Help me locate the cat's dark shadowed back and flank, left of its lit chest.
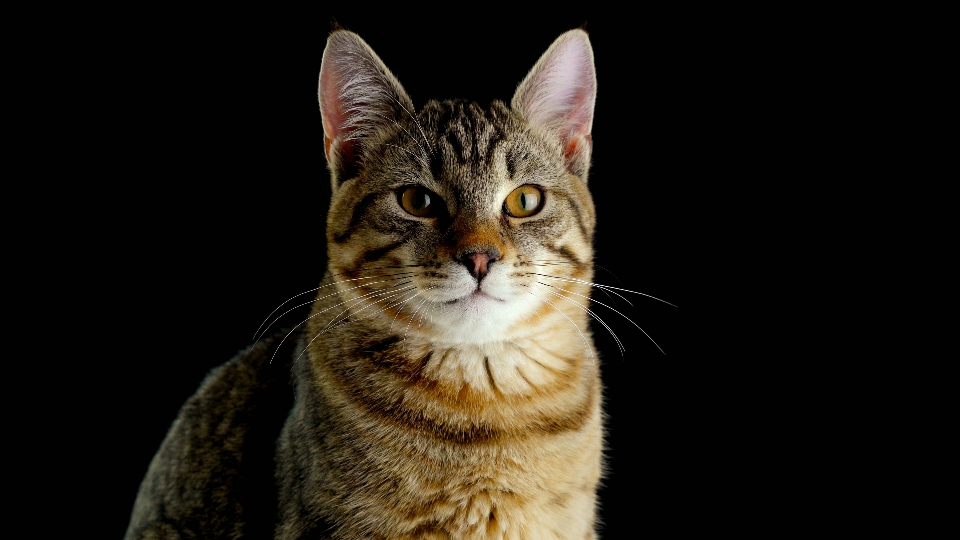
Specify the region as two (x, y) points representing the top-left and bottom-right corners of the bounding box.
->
(125, 332), (296, 539)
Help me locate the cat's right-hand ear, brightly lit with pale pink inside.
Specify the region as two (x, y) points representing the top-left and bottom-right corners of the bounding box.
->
(510, 29), (597, 182)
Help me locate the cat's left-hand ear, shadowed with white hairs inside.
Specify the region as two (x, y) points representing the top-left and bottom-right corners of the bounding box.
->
(317, 30), (413, 191)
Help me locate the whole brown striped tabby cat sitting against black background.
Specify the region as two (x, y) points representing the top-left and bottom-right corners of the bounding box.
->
(126, 30), (603, 540)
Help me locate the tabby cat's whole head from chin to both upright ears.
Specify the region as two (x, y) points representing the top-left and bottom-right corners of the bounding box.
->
(319, 30), (596, 343)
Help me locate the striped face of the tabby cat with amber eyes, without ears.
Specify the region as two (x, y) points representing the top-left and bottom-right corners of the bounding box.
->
(327, 102), (594, 342)
